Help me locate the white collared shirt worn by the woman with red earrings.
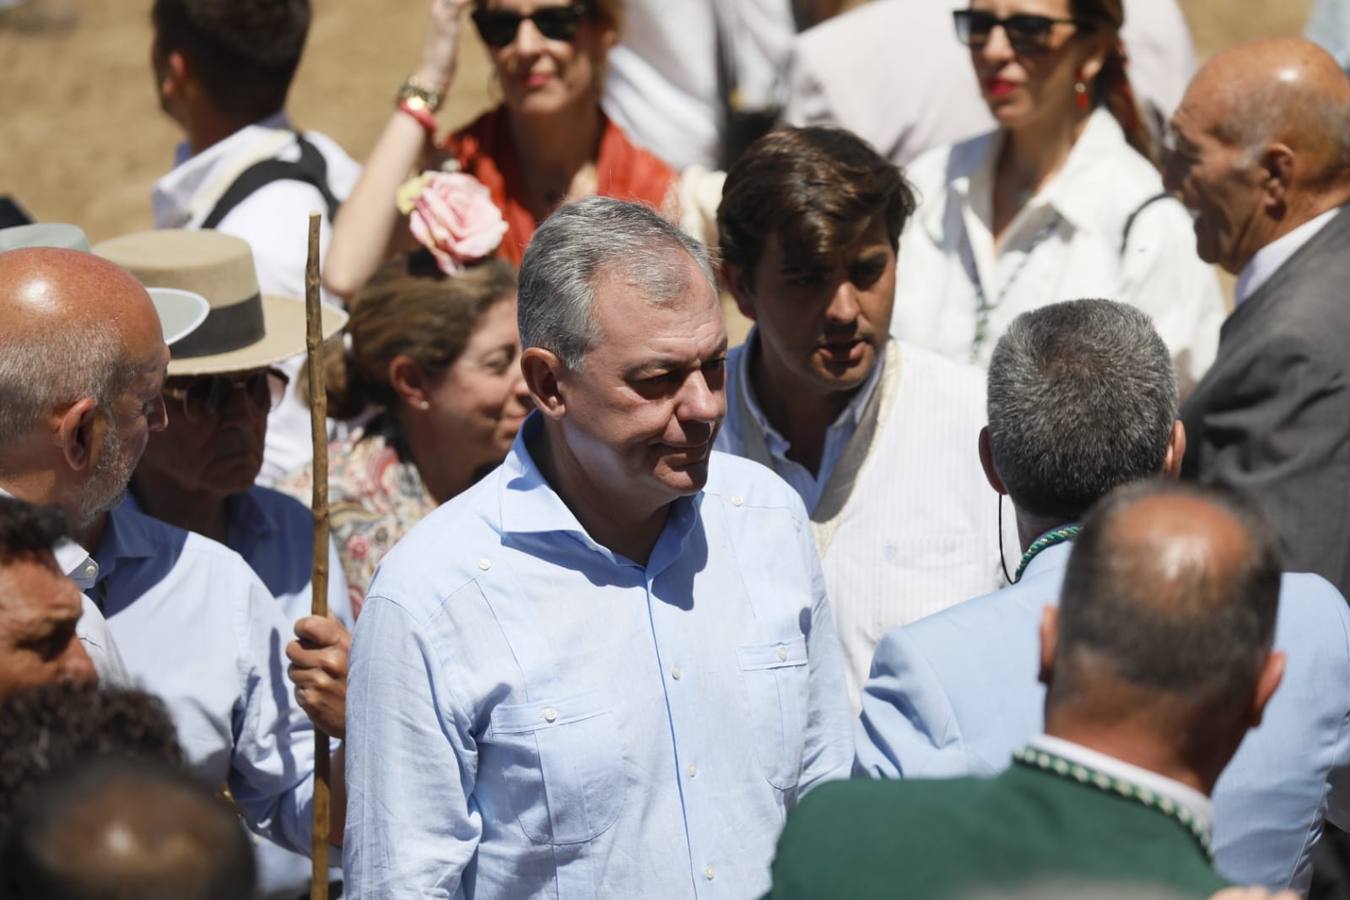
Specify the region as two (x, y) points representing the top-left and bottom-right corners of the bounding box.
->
(891, 109), (1224, 395)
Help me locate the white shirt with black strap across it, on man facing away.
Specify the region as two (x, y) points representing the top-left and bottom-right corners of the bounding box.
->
(151, 112), (360, 493)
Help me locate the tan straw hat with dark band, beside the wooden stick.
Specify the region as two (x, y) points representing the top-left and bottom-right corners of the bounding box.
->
(93, 228), (347, 376)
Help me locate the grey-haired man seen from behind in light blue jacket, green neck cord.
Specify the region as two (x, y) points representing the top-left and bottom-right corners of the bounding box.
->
(856, 300), (1350, 888)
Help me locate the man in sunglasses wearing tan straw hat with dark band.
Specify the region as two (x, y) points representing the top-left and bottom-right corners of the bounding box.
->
(95, 229), (351, 896)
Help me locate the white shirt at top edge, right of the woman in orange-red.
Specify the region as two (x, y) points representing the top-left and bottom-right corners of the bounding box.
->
(602, 0), (797, 170)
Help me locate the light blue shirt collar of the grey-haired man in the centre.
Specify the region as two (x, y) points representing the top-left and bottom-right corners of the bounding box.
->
(500, 410), (702, 568)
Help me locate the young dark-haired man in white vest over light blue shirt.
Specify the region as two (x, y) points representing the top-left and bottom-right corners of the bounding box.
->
(717, 128), (1011, 706)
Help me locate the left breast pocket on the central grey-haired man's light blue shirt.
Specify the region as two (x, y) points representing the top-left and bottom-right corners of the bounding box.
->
(483, 691), (626, 845)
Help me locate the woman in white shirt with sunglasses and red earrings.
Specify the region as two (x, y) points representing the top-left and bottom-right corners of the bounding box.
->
(892, 0), (1224, 391)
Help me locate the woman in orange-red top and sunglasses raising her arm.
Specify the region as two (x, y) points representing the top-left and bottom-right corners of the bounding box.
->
(324, 0), (679, 297)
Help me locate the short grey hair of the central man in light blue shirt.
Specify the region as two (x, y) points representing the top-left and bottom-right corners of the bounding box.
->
(517, 197), (717, 371)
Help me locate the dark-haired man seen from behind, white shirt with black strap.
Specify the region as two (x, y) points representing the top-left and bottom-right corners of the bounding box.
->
(151, 0), (360, 483)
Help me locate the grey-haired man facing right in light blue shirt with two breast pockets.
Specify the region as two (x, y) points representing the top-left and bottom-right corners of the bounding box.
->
(344, 198), (852, 899)
